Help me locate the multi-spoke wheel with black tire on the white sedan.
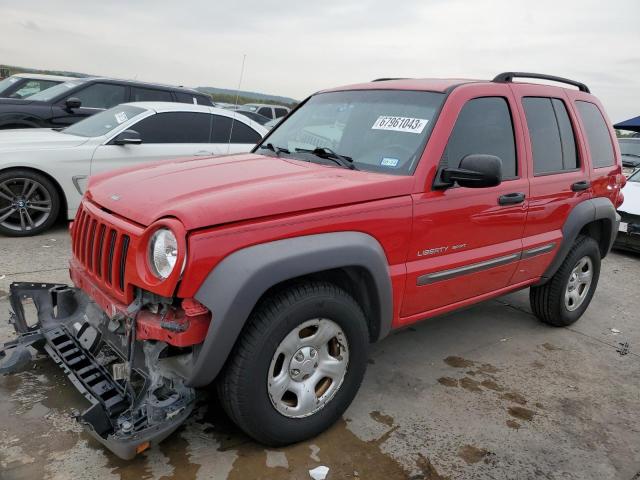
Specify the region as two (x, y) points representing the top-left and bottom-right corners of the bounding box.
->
(0, 170), (60, 237)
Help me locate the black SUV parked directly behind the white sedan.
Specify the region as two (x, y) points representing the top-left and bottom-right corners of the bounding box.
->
(0, 78), (213, 129)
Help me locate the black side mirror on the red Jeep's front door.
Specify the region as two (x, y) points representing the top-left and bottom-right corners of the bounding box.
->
(440, 154), (502, 188)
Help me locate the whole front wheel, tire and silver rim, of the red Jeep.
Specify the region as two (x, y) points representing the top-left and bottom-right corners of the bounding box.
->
(217, 282), (369, 446)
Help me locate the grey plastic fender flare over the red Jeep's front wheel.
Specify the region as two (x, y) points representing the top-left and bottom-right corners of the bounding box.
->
(188, 231), (393, 387)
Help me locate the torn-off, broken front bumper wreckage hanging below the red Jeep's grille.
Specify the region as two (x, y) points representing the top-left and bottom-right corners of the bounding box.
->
(0, 283), (200, 459)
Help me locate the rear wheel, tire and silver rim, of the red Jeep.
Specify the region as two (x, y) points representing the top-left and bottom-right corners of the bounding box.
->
(529, 235), (600, 327)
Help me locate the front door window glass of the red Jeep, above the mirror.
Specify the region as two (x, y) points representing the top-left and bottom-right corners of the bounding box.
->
(441, 97), (518, 179)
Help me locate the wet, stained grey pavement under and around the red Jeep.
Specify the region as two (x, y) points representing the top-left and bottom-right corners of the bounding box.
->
(0, 226), (640, 480)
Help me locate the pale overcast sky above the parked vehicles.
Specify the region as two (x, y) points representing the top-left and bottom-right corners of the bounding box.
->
(0, 0), (640, 122)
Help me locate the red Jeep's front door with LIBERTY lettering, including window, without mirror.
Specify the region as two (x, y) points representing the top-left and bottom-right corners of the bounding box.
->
(401, 90), (529, 323)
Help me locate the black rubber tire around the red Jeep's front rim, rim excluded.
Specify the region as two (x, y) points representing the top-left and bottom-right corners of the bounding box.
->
(217, 282), (369, 447)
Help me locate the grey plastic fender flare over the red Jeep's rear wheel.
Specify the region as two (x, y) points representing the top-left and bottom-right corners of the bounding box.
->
(538, 197), (620, 285)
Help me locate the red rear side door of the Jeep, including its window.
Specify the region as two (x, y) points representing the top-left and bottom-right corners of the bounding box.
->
(511, 84), (592, 282)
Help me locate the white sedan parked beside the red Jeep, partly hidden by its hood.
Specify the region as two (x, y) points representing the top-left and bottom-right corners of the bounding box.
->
(0, 102), (267, 236)
